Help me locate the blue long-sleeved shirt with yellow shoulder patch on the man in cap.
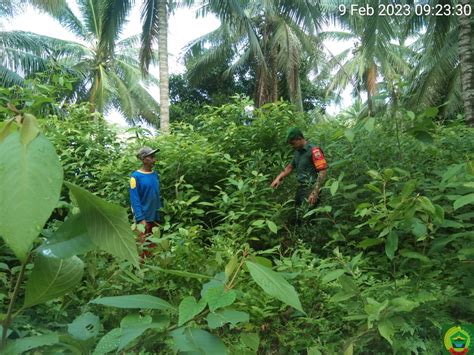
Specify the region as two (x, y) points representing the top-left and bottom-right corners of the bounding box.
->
(129, 170), (162, 223)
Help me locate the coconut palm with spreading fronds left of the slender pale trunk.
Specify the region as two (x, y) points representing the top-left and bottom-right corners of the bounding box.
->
(0, 0), (158, 125)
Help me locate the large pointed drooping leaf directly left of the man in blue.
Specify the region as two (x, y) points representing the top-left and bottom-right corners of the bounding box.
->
(66, 182), (138, 265)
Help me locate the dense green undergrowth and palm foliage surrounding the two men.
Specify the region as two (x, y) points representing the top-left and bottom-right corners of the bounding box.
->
(0, 0), (474, 354)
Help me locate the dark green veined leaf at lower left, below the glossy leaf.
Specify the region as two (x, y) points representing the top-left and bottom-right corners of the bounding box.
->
(24, 254), (84, 307)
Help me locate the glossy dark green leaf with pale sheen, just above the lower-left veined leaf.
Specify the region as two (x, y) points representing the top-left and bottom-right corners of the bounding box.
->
(39, 214), (96, 259)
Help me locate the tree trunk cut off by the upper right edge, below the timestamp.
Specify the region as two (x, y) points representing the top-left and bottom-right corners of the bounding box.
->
(459, 0), (474, 126)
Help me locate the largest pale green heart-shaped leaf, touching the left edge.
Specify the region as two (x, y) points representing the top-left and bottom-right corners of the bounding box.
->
(0, 132), (63, 262)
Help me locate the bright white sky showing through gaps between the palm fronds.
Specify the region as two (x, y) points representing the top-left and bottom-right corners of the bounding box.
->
(0, 1), (351, 127)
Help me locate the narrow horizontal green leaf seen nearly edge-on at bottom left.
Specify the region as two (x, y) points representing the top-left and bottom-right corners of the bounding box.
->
(90, 295), (176, 312)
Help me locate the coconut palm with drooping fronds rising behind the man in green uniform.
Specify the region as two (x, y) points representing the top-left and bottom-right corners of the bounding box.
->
(181, 0), (320, 110)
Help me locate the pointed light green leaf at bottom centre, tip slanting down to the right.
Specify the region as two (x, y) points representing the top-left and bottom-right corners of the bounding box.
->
(245, 261), (304, 313)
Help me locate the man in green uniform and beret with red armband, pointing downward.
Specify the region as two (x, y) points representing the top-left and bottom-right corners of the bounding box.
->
(271, 127), (327, 207)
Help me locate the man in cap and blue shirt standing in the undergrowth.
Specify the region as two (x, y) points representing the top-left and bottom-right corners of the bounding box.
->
(129, 147), (162, 257)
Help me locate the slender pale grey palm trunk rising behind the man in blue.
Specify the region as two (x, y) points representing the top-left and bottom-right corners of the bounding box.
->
(158, 0), (170, 133)
